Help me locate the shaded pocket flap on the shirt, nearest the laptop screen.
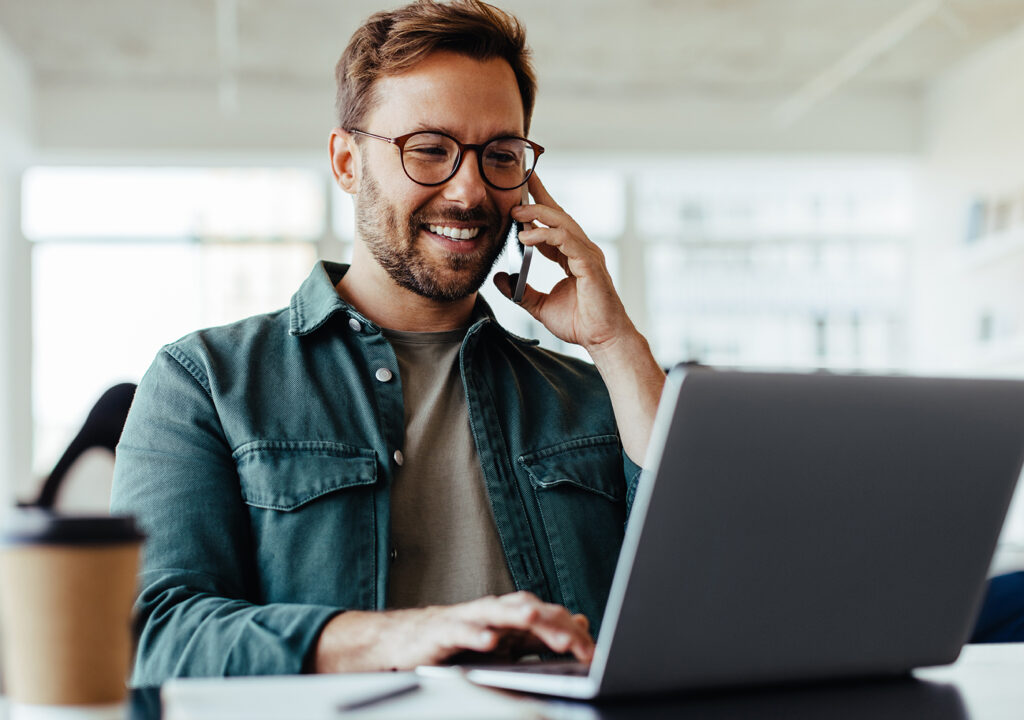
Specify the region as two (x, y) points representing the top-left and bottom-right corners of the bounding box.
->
(518, 435), (626, 502)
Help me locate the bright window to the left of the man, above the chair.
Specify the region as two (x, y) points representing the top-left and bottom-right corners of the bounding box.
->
(23, 168), (327, 475)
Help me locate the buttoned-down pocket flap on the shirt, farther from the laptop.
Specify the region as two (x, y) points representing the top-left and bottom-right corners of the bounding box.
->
(232, 440), (377, 512)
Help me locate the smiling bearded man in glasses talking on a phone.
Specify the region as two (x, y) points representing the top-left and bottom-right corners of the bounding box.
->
(113, 0), (664, 684)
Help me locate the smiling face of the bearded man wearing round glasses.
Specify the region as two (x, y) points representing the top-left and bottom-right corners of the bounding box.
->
(355, 52), (523, 300)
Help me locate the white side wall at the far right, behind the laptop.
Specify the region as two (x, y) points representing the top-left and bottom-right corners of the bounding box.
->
(911, 21), (1024, 568)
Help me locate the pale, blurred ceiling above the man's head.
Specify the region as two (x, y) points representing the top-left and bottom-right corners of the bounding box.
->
(0, 0), (1024, 150)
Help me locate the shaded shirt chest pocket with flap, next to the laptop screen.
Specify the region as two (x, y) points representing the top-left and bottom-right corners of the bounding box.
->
(517, 435), (626, 634)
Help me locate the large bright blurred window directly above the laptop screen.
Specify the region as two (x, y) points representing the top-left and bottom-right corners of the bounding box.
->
(636, 159), (914, 370)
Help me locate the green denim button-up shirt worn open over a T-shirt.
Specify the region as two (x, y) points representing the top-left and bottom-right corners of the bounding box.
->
(112, 262), (640, 685)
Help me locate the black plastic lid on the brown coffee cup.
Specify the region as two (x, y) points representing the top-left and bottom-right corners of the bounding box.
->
(0, 510), (145, 545)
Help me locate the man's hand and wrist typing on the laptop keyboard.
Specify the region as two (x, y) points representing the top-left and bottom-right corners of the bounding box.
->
(310, 592), (594, 673)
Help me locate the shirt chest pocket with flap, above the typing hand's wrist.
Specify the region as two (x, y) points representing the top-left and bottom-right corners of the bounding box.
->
(233, 440), (377, 609)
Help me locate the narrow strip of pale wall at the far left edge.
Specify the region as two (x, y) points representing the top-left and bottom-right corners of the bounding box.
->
(0, 29), (32, 505)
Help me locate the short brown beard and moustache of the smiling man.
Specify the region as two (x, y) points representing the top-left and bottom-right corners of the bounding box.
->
(355, 168), (512, 301)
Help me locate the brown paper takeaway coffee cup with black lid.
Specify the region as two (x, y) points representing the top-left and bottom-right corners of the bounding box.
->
(0, 510), (142, 706)
